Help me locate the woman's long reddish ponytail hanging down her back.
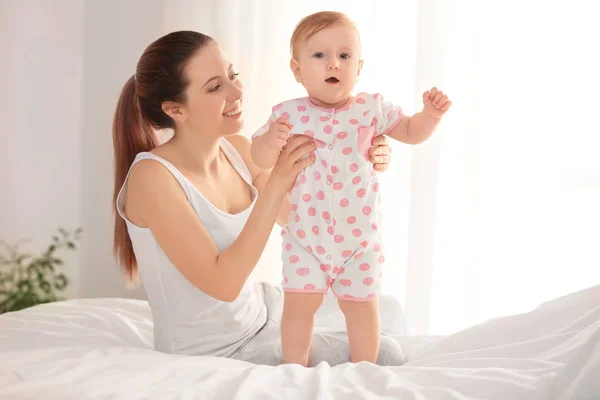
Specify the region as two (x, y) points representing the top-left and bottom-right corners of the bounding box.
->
(113, 76), (158, 282)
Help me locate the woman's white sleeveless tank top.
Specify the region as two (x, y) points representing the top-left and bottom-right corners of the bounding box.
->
(117, 138), (267, 357)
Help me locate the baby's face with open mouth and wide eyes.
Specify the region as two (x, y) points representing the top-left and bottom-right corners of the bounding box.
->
(290, 25), (362, 107)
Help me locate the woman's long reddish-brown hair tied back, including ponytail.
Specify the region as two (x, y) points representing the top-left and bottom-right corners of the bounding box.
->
(113, 31), (214, 280)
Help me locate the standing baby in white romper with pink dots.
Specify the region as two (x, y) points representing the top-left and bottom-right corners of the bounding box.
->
(252, 12), (451, 366)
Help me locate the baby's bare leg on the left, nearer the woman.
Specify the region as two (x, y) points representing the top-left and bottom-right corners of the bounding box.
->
(281, 292), (323, 367)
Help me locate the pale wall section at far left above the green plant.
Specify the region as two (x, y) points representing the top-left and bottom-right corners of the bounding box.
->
(0, 0), (84, 295)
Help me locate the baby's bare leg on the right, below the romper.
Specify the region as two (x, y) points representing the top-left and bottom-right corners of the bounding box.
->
(338, 300), (381, 363)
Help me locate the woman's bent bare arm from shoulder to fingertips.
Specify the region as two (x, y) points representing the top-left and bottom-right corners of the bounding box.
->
(127, 137), (316, 301)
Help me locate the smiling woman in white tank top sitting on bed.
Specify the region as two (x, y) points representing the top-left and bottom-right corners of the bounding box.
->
(113, 31), (401, 365)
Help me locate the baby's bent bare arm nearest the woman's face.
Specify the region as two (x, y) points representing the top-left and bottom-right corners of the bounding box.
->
(250, 117), (292, 169)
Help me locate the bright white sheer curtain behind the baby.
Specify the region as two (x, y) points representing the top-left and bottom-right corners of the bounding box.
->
(165, 0), (600, 334)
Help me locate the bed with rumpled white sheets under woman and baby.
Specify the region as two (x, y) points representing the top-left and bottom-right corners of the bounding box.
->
(0, 285), (600, 400)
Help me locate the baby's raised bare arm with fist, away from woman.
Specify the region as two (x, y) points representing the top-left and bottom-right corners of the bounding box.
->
(387, 88), (452, 144)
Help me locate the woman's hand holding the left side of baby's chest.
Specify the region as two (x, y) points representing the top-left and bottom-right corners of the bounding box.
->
(265, 135), (317, 197)
